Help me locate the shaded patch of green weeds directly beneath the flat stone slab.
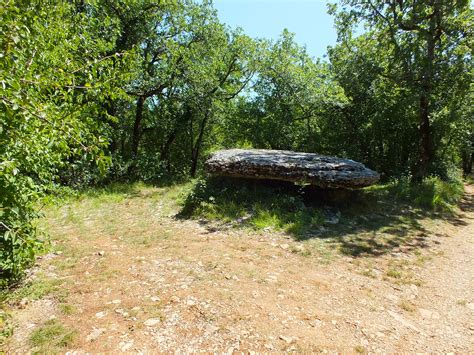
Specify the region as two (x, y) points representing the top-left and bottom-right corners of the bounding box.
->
(180, 178), (324, 234)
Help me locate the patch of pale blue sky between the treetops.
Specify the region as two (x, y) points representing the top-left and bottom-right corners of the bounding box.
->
(214, 0), (337, 58)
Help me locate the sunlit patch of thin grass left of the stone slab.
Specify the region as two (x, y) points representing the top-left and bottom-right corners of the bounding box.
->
(41, 183), (189, 253)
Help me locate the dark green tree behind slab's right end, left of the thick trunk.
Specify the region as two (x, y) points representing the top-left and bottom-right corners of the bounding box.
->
(328, 34), (418, 176)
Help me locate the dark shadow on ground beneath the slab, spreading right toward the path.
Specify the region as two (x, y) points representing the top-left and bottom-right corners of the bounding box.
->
(178, 178), (473, 257)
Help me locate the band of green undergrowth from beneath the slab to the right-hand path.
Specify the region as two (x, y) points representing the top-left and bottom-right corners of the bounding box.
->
(180, 177), (463, 236)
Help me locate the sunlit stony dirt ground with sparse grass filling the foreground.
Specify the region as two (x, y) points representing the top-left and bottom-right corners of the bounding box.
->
(0, 185), (474, 353)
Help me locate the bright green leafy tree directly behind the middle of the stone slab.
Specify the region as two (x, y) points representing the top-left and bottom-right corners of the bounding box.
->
(227, 30), (345, 153)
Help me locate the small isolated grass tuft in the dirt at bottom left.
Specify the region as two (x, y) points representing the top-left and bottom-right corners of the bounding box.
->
(29, 319), (77, 354)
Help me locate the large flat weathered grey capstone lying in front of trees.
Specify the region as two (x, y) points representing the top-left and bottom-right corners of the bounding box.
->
(205, 149), (380, 188)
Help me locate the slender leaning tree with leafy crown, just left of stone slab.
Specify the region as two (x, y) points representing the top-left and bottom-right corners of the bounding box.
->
(185, 28), (256, 176)
